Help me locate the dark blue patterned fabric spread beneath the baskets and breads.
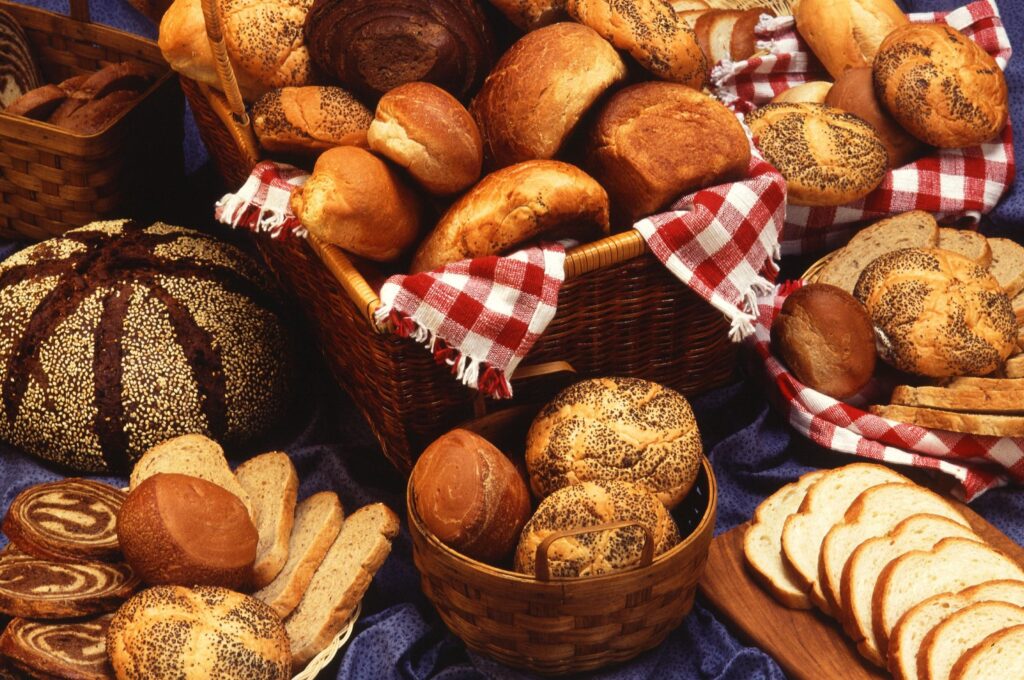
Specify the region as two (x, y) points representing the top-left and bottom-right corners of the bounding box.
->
(0, 0), (1024, 680)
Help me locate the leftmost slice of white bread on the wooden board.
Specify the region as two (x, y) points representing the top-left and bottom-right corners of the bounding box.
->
(743, 470), (826, 609)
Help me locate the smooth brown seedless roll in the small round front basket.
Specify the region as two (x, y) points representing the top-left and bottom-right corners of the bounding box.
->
(412, 429), (530, 564)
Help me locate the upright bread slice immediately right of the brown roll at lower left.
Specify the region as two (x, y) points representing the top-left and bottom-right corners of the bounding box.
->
(234, 451), (299, 589)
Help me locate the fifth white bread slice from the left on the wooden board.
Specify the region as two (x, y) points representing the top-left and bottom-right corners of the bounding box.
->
(871, 538), (1024, 652)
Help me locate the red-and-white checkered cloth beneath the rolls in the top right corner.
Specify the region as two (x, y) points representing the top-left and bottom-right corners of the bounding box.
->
(712, 0), (1019, 255)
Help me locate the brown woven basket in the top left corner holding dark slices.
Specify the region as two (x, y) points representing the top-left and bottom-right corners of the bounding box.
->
(0, 0), (184, 240)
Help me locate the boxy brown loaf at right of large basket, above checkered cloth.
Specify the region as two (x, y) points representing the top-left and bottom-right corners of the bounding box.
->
(587, 82), (751, 224)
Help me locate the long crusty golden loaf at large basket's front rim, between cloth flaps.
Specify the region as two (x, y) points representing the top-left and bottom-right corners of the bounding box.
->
(412, 161), (608, 272)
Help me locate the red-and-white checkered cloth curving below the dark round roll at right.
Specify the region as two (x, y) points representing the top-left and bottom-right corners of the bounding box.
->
(749, 282), (1024, 502)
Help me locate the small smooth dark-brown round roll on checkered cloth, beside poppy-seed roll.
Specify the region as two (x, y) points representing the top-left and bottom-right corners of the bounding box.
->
(771, 284), (876, 399)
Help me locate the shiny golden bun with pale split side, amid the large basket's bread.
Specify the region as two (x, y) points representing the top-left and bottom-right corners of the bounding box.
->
(367, 83), (483, 196)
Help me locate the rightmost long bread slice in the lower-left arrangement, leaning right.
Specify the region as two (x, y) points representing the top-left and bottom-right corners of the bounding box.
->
(285, 503), (399, 672)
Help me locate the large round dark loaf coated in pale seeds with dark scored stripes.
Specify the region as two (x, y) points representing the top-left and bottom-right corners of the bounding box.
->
(0, 221), (291, 471)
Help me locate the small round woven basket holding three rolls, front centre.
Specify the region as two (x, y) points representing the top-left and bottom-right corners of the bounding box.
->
(407, 409), (718, 675)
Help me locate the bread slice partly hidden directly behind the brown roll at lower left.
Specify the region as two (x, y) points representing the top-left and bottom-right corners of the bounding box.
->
(128, 434), (256, 517)
